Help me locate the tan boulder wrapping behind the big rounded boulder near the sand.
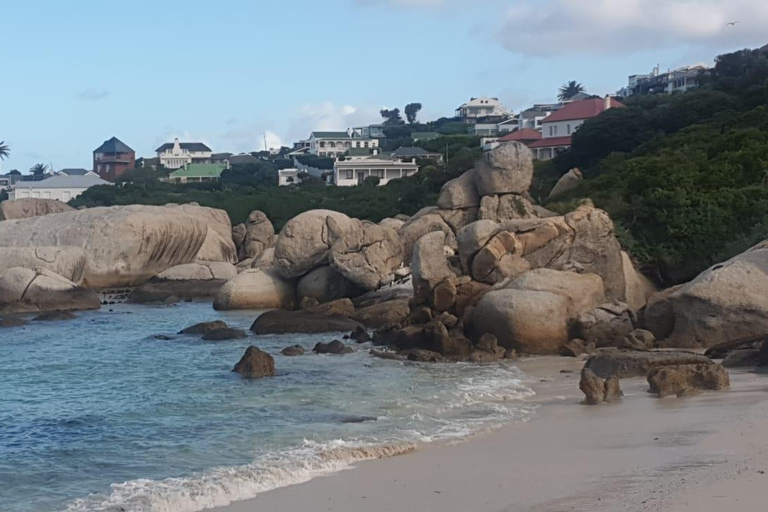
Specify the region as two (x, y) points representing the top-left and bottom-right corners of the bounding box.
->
(507, 268), (605, 318)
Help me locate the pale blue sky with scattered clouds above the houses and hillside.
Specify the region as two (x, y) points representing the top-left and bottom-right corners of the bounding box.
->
(0, 0), (768, 173)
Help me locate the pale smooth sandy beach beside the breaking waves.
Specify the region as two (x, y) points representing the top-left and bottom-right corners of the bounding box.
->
(217, 357), (768, 512)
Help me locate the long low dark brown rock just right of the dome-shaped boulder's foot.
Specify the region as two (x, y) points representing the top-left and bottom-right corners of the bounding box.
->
(251, 309), (362, 334)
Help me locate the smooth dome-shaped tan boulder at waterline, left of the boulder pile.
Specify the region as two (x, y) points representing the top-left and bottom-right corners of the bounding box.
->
(213, 269), (296, 310)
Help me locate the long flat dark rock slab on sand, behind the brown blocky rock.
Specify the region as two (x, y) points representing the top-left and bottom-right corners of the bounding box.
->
(585, 349), (710, 379)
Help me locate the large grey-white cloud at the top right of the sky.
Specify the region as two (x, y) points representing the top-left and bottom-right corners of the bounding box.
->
(495, 0), (768, 56)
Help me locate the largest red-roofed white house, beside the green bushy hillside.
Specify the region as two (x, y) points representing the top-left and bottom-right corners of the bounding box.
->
(527, 96), (624, 160)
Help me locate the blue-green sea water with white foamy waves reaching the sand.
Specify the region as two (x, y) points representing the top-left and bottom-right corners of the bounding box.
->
(0, 303), (534, 512)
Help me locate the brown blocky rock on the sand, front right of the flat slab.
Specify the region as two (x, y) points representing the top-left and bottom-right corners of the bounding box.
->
(648, 362), (730, 398)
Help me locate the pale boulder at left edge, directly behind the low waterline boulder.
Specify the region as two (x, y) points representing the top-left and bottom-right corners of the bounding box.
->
(0, 247), (87, 284)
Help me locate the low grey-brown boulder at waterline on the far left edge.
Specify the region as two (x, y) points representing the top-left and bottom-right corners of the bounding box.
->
(0, 267), (101, 314)
